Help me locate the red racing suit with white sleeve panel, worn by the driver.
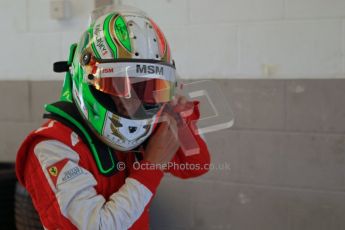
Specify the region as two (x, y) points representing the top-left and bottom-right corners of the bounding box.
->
(16, 102), (210, 230)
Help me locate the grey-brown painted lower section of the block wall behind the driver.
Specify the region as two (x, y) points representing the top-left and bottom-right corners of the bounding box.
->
(0, 80), (345, 230)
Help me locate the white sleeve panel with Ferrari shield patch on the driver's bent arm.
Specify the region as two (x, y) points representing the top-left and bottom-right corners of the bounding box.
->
(34, 140), (153, 230)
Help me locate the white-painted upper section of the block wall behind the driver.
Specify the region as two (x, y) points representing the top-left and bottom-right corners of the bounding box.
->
(0, 0), (345, 80)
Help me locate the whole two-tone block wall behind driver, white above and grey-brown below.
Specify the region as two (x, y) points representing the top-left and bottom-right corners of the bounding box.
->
(0, 0), (345, 230)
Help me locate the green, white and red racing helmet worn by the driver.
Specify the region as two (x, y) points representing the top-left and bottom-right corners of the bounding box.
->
(70, 6), (176, 151)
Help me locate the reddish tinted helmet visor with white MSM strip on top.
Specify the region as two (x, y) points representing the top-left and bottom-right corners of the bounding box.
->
(83, 62), (176, 104)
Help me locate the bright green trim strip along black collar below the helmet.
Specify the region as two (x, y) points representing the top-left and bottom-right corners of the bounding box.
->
(45, 104), (115, 174)
